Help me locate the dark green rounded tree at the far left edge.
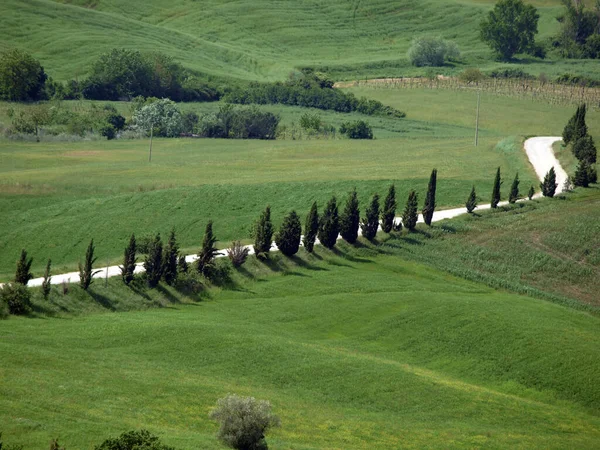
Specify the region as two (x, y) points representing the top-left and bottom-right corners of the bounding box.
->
(0, 49), (48, 102)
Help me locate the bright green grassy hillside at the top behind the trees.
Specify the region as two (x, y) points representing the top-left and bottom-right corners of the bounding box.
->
(0, 0), (598, 80)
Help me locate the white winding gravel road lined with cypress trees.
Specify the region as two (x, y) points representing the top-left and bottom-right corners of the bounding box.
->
(15, 137), (567, 286)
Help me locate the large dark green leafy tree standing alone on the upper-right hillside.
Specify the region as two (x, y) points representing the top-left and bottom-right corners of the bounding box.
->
(480, 0), (540, 61)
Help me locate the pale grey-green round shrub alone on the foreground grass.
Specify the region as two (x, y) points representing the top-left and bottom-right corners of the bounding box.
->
(210, 395), (279, 450)
